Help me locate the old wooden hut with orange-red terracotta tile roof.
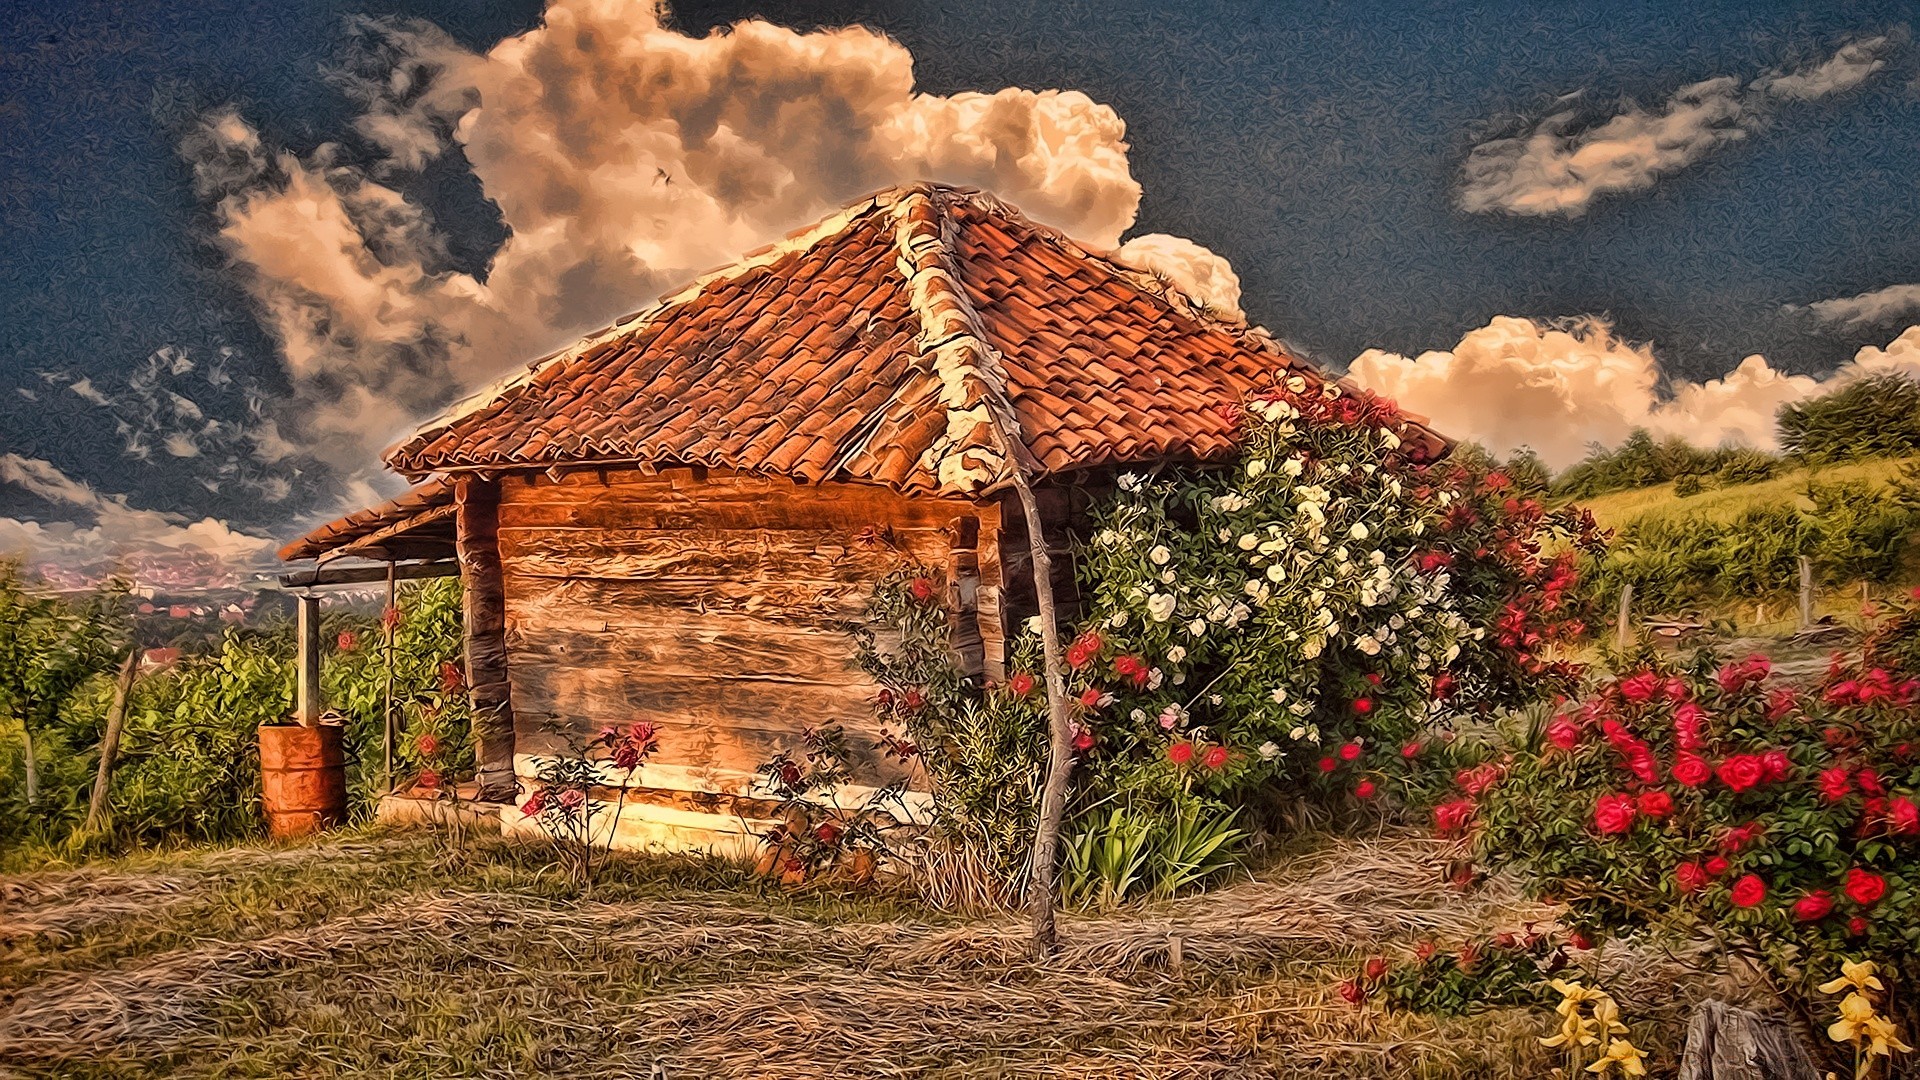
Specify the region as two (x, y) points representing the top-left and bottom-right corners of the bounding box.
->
(282, 184), (1432, 847)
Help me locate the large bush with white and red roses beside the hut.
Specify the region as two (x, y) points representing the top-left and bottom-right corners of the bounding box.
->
(1044, 377), (1601, 814)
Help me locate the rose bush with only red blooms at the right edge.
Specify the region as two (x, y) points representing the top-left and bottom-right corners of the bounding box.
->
(1459, 630), (1920, 1045)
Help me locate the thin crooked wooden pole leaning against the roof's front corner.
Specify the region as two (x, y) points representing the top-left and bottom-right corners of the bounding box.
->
(1012, 465), (1073, 959)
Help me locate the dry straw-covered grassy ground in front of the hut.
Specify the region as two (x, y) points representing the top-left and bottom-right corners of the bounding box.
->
(0, 818), (1672, 1078)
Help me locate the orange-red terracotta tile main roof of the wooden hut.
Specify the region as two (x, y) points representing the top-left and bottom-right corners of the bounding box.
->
(386, 184), (1444, 492)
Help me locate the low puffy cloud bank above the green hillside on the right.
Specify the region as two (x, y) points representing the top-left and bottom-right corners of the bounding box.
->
(1350, 315), (1920, 469)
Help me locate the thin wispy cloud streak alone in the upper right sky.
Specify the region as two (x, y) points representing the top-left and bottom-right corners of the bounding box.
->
(1459, 37), (1893, 217)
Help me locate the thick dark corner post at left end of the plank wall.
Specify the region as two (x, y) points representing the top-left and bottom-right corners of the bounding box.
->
(453, 477), (515, 801)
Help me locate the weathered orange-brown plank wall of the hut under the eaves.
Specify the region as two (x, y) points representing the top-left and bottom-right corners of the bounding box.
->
(497, 469), (998, 792)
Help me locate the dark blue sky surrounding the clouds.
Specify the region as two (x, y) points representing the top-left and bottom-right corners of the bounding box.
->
(0, 0), (1920, 557)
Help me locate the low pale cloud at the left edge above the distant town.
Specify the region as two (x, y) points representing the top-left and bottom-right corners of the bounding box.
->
(0, 454), (273, 588)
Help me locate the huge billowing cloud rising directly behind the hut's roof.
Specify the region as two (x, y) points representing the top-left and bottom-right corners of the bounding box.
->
(182, 0), (1238, 473)
